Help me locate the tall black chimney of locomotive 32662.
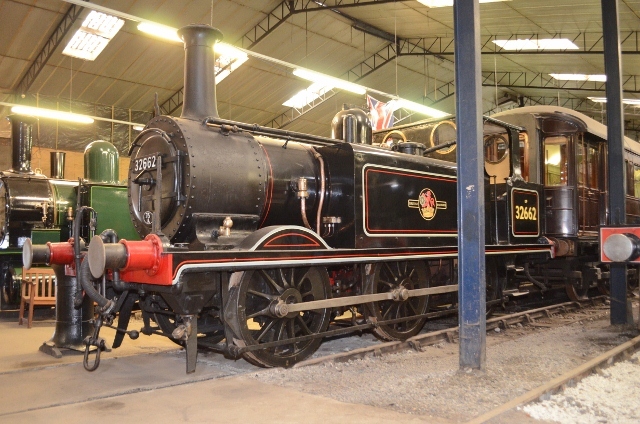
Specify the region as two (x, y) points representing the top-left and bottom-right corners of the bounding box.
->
(178, 24), (222, 120)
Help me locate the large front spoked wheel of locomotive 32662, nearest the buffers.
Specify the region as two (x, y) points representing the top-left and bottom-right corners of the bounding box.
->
(225, 267), (331, 367)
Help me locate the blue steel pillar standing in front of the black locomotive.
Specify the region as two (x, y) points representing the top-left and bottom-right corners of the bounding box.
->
(453, 0), (487, 369)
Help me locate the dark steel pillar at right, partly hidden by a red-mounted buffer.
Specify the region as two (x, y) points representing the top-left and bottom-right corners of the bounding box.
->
(602, 0), (627, 324)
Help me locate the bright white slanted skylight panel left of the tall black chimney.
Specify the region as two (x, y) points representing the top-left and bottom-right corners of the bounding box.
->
(62, 10), (124, 60)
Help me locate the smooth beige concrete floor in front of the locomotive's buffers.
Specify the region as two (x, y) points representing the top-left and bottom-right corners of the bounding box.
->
(0, 314), (440, 424)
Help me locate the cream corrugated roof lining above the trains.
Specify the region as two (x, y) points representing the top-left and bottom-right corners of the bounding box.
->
(0, 0), (640, 142)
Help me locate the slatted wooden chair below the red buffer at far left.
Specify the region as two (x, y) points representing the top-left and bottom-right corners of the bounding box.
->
(18, 268), (56, 328)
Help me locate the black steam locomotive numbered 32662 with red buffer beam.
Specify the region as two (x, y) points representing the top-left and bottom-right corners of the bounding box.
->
(25, 25), (632, 371)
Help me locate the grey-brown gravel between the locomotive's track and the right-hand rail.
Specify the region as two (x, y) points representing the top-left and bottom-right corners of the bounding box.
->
(251, 306), (640, 422)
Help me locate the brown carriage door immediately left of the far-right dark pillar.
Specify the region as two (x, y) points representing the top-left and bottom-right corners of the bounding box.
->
(576, 133), (602, 234)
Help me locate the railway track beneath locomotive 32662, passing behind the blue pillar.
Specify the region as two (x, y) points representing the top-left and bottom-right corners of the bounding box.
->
(293, 296), (606, 368)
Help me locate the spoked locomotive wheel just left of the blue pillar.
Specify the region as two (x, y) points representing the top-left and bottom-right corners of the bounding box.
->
(365, 261), (430, 341)
